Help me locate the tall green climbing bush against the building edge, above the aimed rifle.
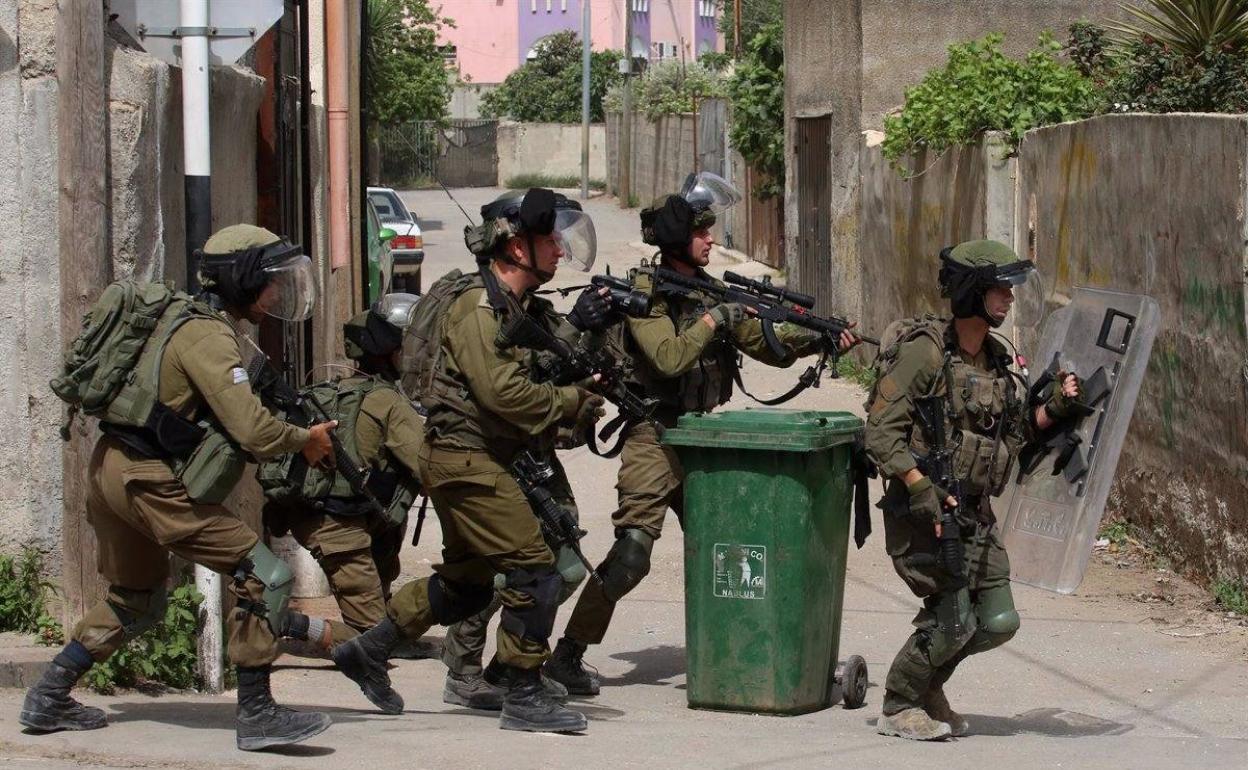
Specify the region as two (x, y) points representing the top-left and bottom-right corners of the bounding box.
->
(728, 21), (784, 198)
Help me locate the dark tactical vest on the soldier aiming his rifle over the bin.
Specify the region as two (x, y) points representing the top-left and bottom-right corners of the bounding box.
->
(620, 271), (740, 414)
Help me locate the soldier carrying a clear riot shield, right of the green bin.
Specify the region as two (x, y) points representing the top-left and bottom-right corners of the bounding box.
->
(866, 241), (1078, 740)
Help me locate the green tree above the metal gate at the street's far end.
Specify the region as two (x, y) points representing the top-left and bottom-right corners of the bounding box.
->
(363, 0), (454, 127)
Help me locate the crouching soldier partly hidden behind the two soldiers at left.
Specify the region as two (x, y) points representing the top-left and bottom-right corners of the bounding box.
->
(257, 293), (424, 650)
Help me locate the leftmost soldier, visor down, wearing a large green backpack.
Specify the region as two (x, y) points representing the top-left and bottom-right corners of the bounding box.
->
(19, 225), (334, 750)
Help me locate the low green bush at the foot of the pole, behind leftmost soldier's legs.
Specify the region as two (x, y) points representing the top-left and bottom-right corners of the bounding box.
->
(86, 583), (203, 694)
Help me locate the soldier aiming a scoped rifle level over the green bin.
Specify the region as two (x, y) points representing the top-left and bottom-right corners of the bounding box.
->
(545, 177), (855, 695)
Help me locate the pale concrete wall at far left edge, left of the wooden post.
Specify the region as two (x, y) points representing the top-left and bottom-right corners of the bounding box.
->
(0, 0), (61, 565)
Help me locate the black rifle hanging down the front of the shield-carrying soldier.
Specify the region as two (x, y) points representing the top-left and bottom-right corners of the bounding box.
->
(915, 374), (971, 639)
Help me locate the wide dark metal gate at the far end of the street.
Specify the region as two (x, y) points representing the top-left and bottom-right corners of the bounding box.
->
(378, 119), (498, 187)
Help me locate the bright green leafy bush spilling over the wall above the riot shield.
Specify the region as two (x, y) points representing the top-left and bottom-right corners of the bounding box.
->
(882, 34), (1099, 170)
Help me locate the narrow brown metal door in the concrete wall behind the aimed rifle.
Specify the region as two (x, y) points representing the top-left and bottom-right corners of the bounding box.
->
(796, 116), (832, 312)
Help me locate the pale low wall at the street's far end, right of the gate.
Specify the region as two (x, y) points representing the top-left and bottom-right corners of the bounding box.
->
(498, 122), (607, 187)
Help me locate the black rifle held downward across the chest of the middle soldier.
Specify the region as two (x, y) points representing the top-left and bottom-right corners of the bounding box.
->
(503, 313), (658, 431)
